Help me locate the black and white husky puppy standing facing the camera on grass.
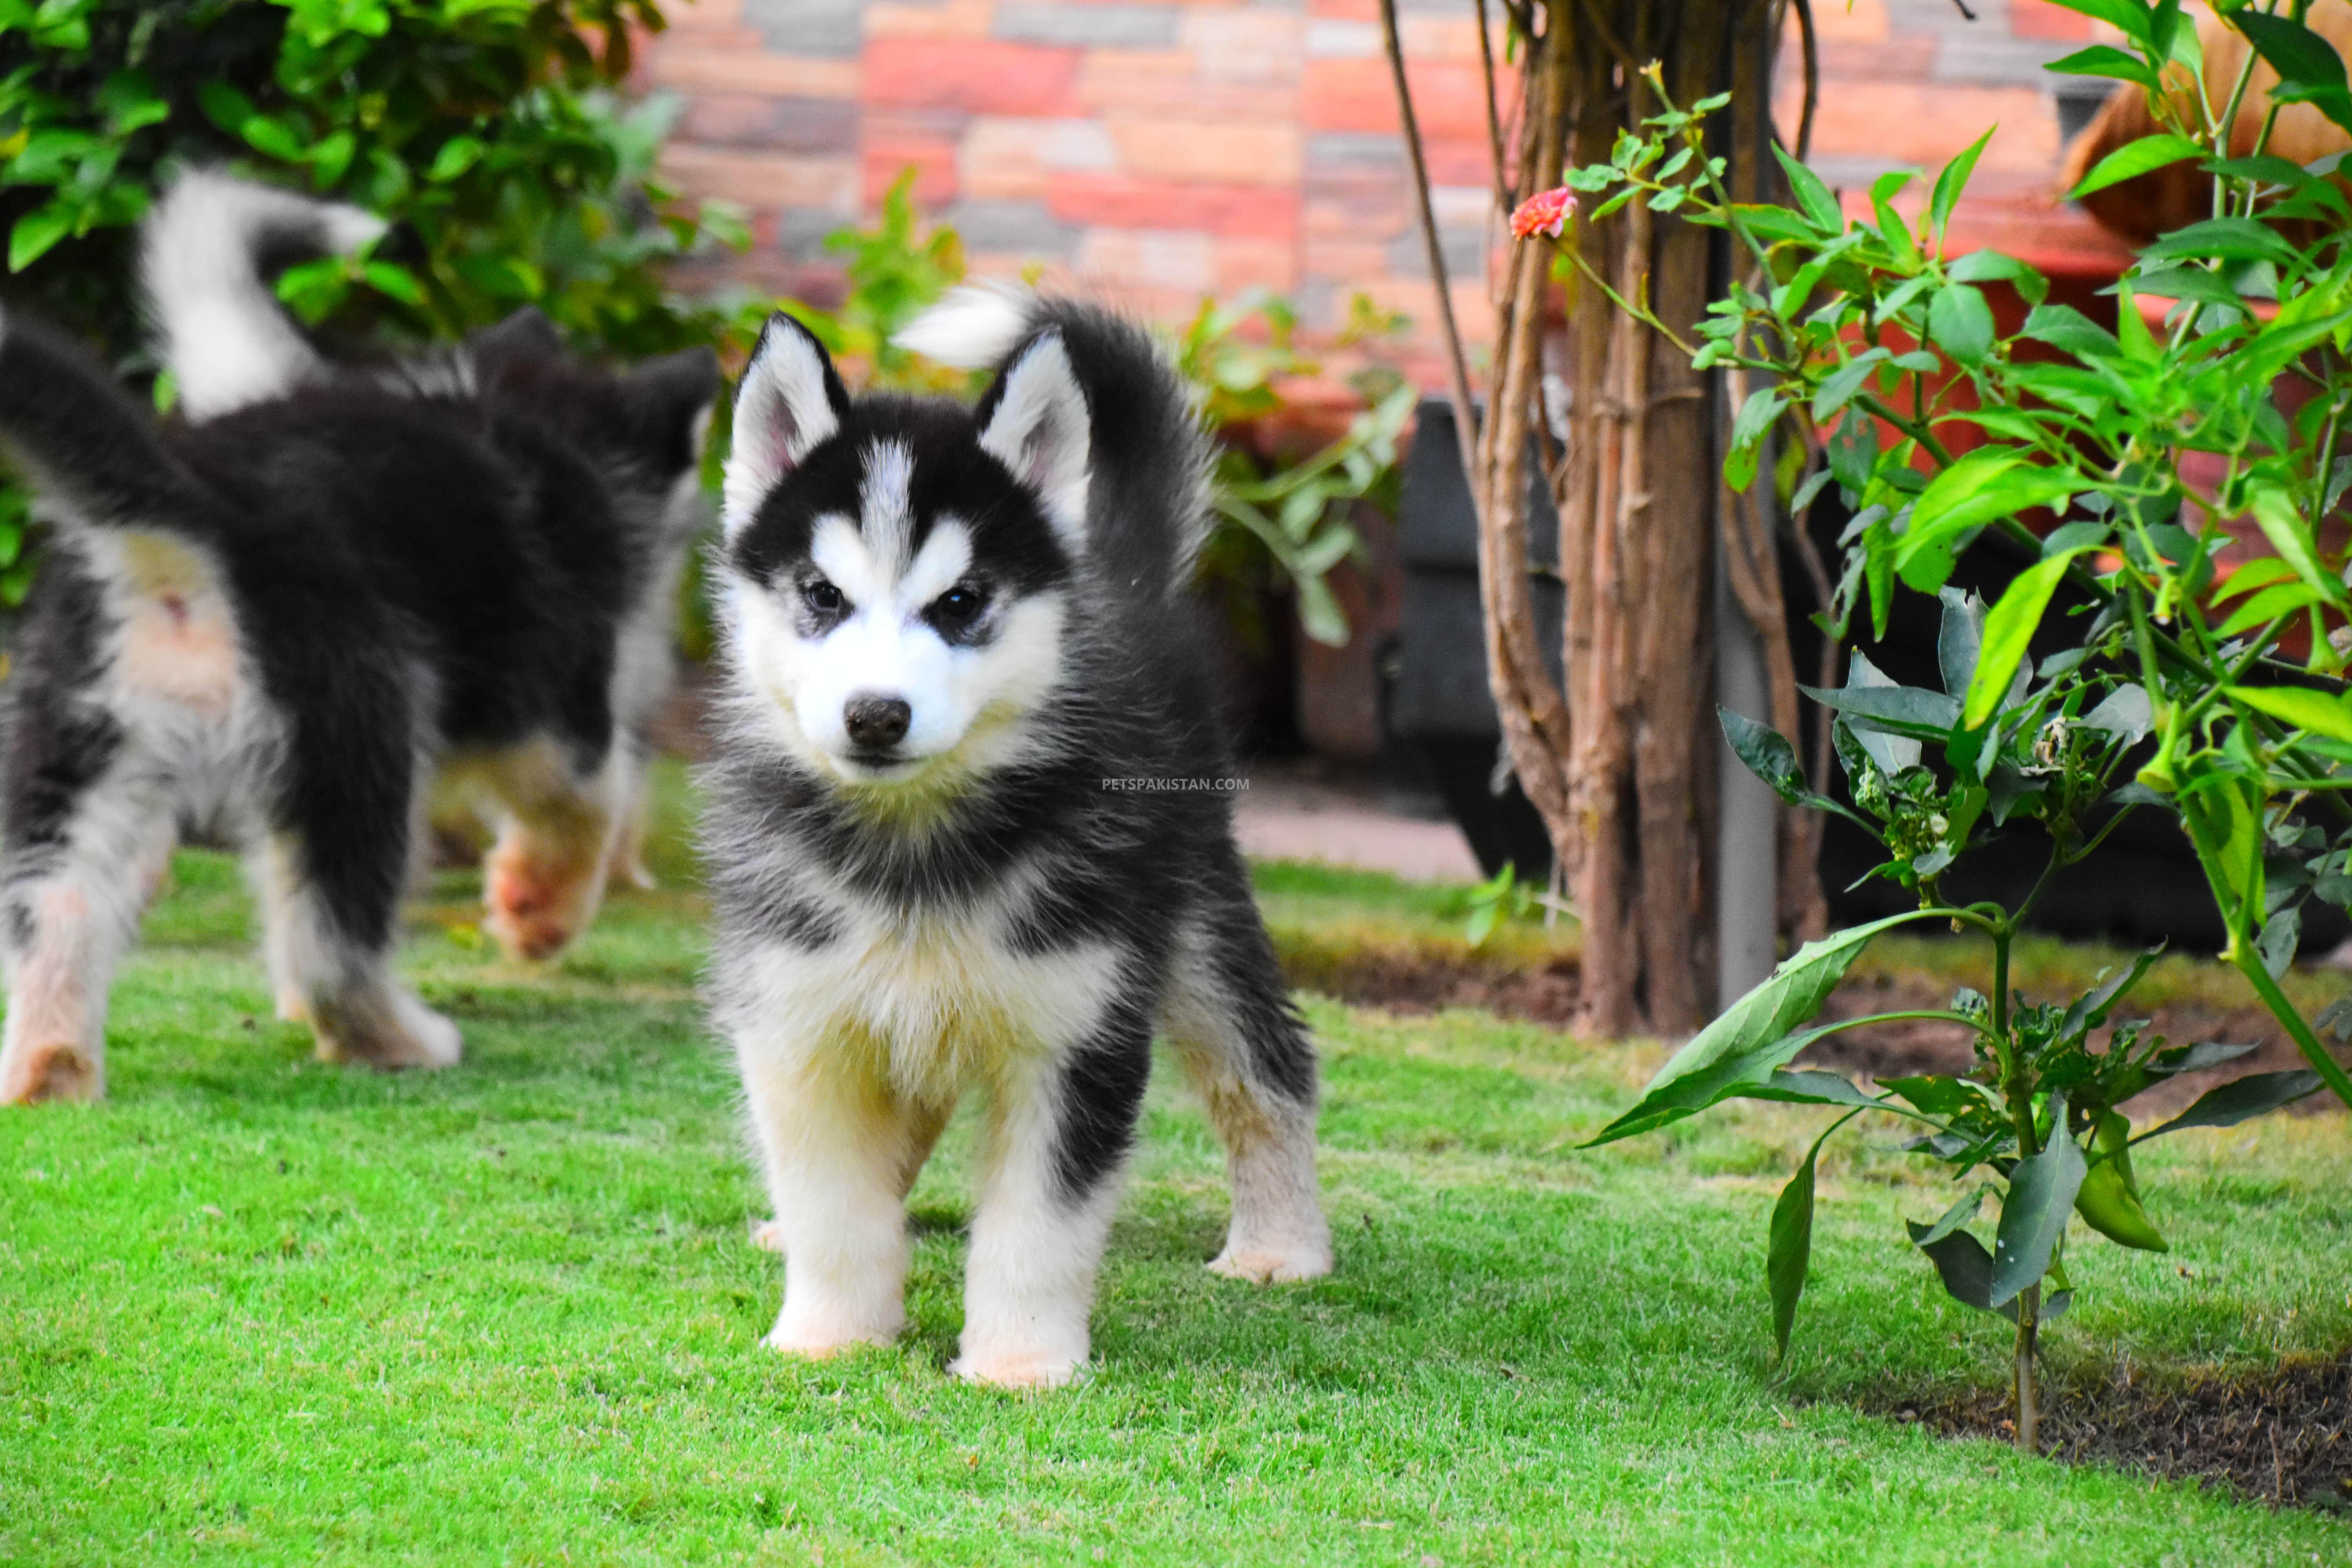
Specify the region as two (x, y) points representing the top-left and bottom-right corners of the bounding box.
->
(708, 292), (1331, 1387)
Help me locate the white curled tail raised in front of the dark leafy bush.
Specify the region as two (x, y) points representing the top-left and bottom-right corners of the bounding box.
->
(139, 169), (383, 418)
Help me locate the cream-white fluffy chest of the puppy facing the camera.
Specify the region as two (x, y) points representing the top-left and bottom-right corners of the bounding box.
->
(743, 896), (1120, 1105)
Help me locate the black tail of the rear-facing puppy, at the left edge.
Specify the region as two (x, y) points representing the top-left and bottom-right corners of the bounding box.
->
(0, 310), (207, 529)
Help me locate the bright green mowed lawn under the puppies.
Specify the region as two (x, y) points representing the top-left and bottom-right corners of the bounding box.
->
(0, 771), (2352, 1568)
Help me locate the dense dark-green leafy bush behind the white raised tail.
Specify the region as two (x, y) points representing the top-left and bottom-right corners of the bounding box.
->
(0, 0), (743, 602)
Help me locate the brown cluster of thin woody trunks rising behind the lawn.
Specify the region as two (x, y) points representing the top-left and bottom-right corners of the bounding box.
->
(1383, 0), (1804, 1034)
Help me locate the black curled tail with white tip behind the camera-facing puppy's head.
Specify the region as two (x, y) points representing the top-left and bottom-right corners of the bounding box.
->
(896, 285), (1211, 592)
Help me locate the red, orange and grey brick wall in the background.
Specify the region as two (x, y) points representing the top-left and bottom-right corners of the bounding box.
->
(647, 0), (2145, 362)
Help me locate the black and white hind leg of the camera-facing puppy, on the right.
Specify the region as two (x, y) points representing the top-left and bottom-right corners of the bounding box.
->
(1167, 858), (1331, 1283)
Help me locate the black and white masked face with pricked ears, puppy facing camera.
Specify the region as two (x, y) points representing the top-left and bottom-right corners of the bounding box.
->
(724, 315), (1087, 790)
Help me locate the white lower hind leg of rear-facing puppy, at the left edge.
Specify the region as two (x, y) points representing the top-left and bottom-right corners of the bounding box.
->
(0, 762), (174, 1105)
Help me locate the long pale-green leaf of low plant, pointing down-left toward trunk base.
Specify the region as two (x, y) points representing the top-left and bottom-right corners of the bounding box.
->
(1581, 910), (1936, 1147)
